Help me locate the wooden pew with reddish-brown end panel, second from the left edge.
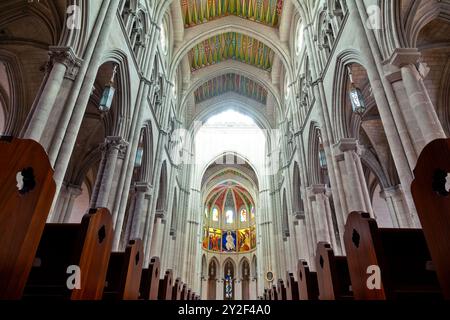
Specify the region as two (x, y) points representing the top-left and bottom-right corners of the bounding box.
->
(24, 209), (114, 300)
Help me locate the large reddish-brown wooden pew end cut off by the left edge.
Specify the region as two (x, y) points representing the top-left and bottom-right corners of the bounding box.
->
(0, 137), (55, 300)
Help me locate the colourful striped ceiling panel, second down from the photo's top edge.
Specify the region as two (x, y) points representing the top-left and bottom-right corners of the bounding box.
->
(188, 32), (275, 71)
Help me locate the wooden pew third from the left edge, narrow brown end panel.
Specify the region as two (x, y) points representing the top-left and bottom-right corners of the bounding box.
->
(103, 239), (144, 300)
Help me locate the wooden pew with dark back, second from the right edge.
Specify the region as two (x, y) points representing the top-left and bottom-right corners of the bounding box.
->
(344, 212), (441, 300)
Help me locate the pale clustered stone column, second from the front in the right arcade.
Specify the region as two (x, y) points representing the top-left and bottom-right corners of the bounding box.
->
(335, 138), (373, 216)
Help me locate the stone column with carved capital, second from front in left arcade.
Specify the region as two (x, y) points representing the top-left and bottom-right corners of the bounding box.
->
(92, 137), (127, 210)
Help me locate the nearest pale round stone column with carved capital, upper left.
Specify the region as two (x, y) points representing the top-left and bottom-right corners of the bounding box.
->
(23, 46), (81, 142)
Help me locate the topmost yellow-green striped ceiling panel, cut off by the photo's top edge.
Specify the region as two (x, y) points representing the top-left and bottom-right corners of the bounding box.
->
(180, 0), (283, 28)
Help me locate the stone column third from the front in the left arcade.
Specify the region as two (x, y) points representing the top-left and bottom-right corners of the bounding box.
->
(130, 182), (151, 239)
